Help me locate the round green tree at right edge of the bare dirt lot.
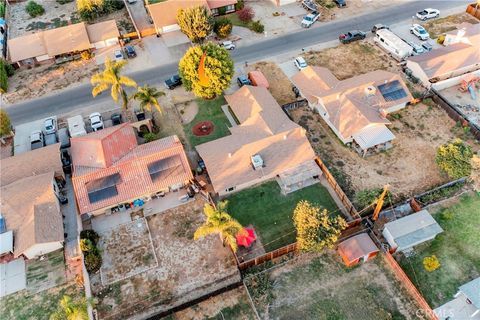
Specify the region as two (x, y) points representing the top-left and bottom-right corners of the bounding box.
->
(435, 139), (473, 179)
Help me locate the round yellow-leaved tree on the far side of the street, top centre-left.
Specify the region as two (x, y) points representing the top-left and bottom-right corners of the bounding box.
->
(177, 6), (214, 43)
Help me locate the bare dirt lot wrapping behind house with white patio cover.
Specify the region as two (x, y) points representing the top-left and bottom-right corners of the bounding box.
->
(291, 103), (479, 198)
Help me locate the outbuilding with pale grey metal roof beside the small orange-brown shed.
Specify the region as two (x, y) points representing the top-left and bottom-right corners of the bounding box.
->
(382, 210), (443, 252)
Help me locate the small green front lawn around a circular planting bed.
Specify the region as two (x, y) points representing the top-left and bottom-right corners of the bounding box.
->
(183, 96), (230, 148)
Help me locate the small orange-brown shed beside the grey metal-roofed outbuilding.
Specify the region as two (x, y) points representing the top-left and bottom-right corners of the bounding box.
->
(338, 233), (379, 267)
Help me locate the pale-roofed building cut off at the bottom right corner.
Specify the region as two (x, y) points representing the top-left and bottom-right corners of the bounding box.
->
(434, 277), (480, 320)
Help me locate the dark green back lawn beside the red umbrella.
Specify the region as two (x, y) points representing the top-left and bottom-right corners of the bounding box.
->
(227, 181), (338, 252)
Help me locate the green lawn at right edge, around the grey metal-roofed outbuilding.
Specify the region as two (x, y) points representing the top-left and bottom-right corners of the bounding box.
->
(400, 195), (480, 308)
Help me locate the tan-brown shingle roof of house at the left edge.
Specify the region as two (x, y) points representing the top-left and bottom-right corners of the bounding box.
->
(1, 172), (64, 256)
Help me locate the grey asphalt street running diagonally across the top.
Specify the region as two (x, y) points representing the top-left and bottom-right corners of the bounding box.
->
(5, 0), (471, 125)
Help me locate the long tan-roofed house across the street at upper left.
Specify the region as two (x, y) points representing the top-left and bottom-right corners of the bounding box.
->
(8, 20), (120, 67)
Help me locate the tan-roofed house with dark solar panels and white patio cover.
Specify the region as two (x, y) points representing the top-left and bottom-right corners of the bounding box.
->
(292, 66), (412, 156)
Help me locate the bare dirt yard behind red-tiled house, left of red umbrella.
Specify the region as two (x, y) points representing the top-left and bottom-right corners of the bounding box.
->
(91, 198), (240, 319)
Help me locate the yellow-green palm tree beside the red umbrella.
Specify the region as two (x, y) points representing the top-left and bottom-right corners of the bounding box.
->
(193, 201), (243, 252)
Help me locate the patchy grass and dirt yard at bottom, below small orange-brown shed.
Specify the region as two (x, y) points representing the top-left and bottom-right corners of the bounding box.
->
(245, 251), (418, 320)
